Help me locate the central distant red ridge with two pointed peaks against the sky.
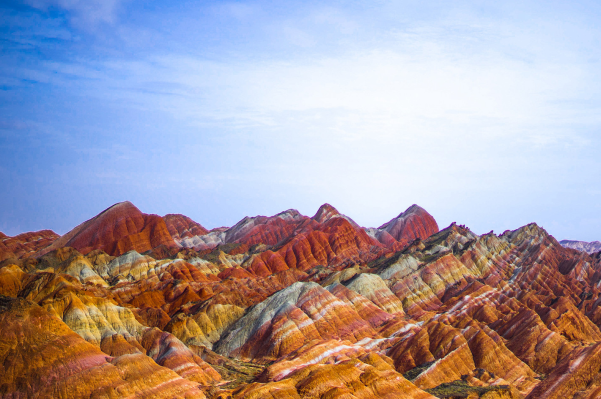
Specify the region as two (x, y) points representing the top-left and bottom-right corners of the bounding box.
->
(179, 204), (438, 276)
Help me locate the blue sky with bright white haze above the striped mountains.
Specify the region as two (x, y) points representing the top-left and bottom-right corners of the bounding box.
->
(0, 0), (601, 241)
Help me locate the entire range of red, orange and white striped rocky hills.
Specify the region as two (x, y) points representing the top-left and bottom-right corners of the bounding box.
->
(0, 202), (601, 399)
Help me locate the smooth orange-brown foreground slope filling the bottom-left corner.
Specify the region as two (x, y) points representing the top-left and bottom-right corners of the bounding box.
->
(0, 297), (204, 399)
